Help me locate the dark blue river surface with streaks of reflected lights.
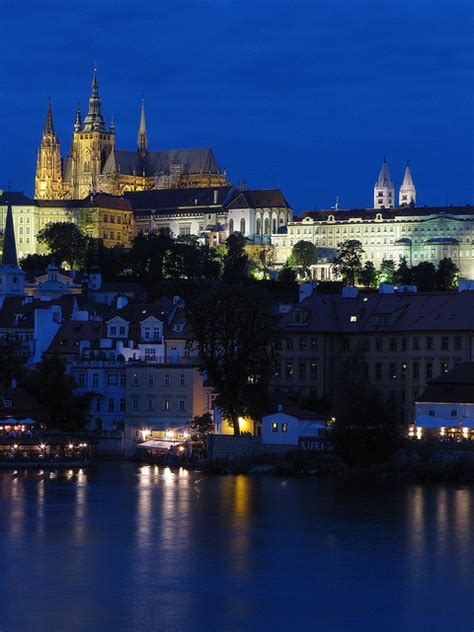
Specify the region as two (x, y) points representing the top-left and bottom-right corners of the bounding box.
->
(0, 463), (474, 632)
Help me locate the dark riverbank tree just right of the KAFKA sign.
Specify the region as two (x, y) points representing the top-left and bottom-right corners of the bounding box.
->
(329, 354), (399, 465)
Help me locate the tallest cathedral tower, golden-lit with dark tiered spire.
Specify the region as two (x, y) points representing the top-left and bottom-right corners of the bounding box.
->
(71, 68), (115, 199)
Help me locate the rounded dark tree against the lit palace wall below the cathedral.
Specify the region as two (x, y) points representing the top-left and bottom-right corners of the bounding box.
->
(37, 222), (89, 268)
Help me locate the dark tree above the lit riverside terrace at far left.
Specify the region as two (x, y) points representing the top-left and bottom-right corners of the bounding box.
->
(25, 354), (92, 431)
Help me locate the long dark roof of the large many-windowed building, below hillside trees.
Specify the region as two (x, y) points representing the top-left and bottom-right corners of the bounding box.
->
(281, 291), (474, 334)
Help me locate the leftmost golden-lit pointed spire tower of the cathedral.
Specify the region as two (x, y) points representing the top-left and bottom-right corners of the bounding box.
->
(35, 101), (62, 200)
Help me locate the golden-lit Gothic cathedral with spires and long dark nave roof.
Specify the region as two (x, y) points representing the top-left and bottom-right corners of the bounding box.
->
(35, 69), (227, 200)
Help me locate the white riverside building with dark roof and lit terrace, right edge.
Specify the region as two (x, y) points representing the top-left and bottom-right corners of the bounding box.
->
(408, 362), (474, 441)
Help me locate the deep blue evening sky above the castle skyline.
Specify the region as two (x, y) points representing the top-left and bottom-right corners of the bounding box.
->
(0, 0), (474, 213)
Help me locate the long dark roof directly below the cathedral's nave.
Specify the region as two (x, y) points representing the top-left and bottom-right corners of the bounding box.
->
(125, 186), (235, 211)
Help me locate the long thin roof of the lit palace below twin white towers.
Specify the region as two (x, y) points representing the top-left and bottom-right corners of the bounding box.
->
(297, 204), (474, 222)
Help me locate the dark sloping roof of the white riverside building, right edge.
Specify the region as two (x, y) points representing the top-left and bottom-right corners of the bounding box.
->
(417, 362), (474, 404)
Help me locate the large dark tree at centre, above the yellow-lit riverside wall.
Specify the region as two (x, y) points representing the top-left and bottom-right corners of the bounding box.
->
(186, 284), (276, 435)
